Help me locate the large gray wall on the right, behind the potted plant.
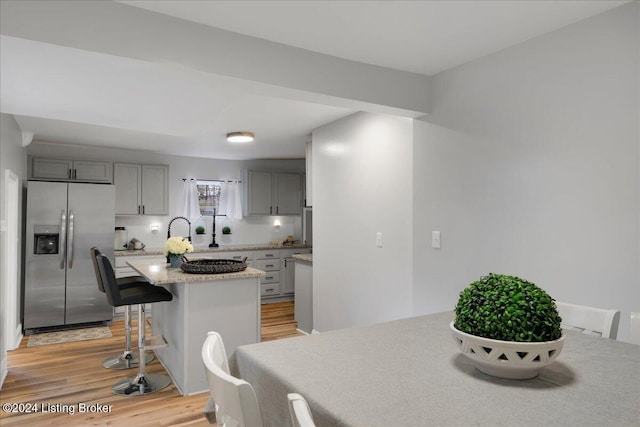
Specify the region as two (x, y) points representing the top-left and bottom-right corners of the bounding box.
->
(413, 2), (640, 339)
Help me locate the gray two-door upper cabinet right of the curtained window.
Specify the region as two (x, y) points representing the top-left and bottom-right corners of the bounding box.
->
(246, 171), (302, 215)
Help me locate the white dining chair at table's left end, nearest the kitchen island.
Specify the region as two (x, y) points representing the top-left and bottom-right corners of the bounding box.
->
(202, 331), (262, 427)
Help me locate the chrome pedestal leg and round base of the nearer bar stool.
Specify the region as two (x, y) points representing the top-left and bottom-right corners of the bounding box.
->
(112, 304), (171, 396)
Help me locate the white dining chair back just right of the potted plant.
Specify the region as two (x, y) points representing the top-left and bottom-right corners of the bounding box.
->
(556, 301), (620, 340)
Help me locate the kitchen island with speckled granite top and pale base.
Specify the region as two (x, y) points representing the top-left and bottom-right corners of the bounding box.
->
(127, 259), (265, 395)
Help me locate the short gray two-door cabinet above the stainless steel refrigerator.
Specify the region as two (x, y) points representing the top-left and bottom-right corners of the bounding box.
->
(31, 157), (113, 183)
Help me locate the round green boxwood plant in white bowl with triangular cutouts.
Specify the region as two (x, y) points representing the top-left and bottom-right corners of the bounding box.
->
(450, 273), (564, 379)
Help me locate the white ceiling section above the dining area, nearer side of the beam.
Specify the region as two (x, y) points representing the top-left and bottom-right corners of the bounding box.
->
(118, 0), (626, 75)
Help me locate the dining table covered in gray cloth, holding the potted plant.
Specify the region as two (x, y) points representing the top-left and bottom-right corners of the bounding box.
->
(230, 312), (640, 427)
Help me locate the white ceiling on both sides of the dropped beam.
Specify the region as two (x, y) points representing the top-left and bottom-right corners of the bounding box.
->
(0, 0), (626, 159)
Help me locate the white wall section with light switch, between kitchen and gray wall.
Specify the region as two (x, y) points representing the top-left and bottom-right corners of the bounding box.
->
(312, 113), (413, 332)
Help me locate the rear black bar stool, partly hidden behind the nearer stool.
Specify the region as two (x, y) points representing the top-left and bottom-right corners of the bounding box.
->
(89, 247), (153, 369)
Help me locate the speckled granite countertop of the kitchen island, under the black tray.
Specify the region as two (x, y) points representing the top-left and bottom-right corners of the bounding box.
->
(127, 259), (266, 285)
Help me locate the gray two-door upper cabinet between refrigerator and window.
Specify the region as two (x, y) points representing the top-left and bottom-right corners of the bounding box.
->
(113, 163), (169, 215)
